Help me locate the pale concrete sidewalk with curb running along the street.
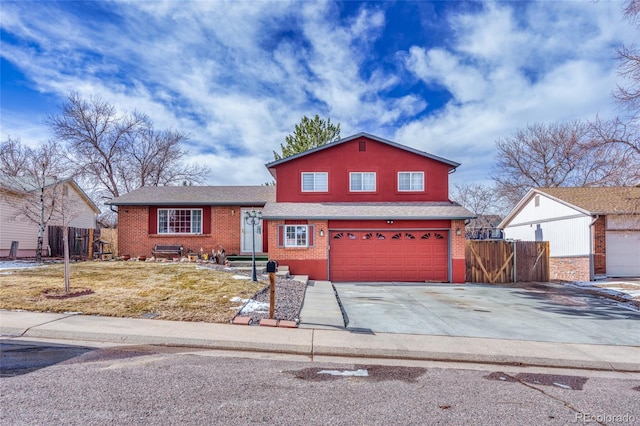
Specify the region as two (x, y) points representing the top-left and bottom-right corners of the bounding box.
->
(0, 311), (640, 372)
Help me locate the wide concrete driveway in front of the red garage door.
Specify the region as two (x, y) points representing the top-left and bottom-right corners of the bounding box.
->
(334, 283), (640, 346)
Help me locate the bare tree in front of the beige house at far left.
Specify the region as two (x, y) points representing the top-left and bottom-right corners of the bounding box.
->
(0, 138), (67, 262)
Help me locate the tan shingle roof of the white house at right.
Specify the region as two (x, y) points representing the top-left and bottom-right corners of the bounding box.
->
(534, 186), (640, 214)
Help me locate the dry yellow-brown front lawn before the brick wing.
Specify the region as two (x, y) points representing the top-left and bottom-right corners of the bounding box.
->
(0, 262), (267, 322)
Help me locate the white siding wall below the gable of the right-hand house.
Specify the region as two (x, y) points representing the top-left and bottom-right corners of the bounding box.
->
(504, 215), (591, 257)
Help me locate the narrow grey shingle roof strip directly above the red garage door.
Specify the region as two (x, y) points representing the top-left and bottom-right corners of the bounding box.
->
(262, 202), (475, 220)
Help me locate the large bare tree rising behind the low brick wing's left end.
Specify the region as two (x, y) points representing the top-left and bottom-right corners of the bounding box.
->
(48, 93), (208, 205)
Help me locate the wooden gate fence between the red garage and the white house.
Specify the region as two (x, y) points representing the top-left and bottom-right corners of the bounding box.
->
(465, 240), (549, 284)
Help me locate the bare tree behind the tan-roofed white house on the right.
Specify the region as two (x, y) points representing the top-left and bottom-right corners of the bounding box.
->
(492, 121), (639, 205)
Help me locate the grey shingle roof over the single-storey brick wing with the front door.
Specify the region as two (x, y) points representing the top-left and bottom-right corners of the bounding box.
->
(106, 186), (276, 206)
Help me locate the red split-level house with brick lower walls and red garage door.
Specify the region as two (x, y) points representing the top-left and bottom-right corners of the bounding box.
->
(110, 133), (473, 283)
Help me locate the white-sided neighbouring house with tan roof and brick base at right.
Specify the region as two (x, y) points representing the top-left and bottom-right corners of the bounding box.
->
(499, 186), (640, 281)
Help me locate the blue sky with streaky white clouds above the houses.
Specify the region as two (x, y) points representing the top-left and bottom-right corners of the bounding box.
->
(0, 0), (637, 189)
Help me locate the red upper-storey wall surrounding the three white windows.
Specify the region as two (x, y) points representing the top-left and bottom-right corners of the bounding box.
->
(273, 136), (453, 203)
